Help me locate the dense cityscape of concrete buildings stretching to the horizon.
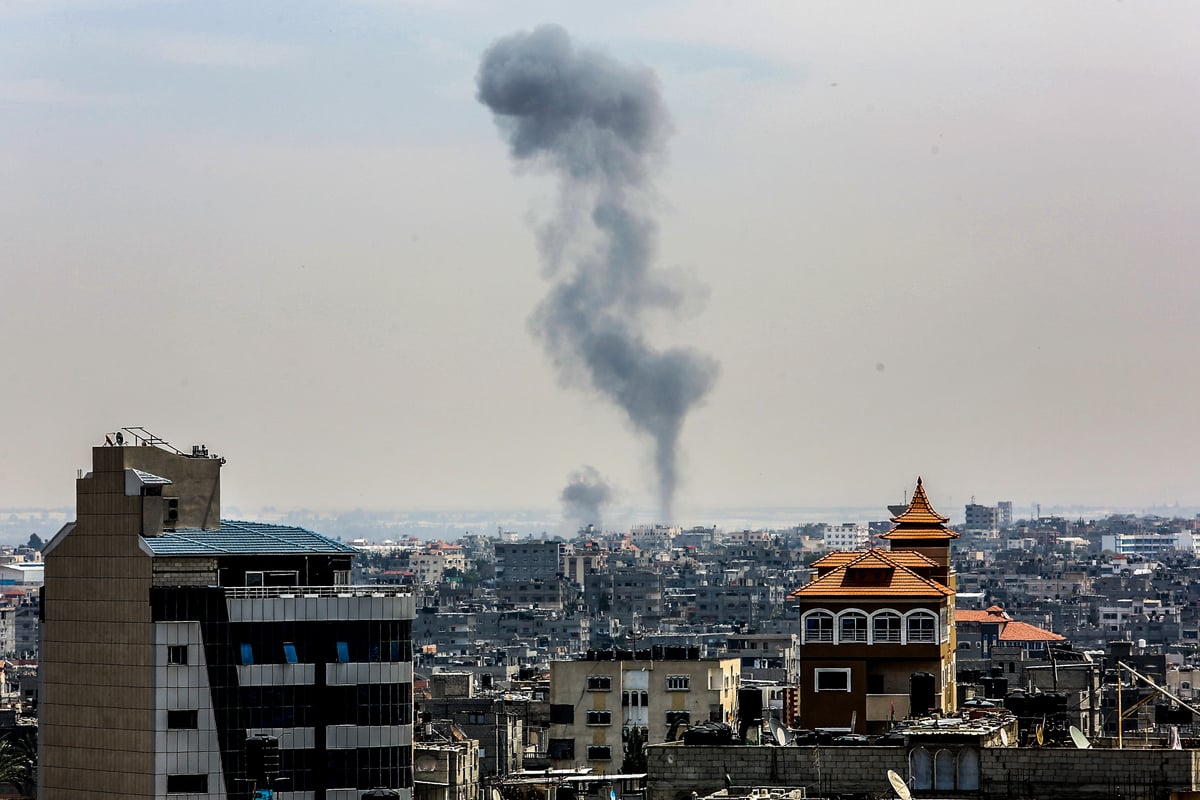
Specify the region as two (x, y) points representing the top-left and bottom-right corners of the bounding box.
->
(18, 429), (1200, 800)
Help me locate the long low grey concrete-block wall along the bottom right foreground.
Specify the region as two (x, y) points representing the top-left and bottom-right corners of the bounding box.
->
(647, 744), (1200, 800)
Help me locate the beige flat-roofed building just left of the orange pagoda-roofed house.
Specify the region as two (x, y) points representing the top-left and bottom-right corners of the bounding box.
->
(548, 651), (742, 772)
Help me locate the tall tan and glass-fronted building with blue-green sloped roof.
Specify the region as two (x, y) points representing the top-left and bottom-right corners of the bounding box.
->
(38, 429), (414, 800)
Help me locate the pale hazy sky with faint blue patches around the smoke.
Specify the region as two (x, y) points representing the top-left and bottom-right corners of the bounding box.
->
(0, 0), (1200, 522)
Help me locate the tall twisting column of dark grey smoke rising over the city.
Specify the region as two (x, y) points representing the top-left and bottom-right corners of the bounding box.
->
(478, 25), (718, 522)
